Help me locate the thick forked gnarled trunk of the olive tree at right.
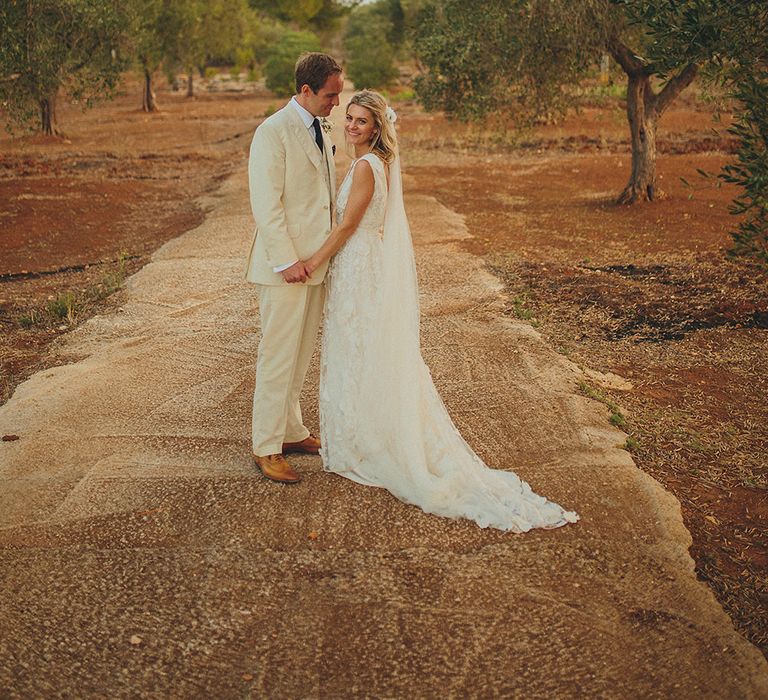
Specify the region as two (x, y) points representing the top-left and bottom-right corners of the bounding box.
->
(608, 39), (698, 204)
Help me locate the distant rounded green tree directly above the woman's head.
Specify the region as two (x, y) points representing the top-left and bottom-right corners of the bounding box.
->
(344, 0), (403, 89)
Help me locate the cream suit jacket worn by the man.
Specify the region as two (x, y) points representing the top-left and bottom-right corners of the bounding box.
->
(246, 103), (336, 285)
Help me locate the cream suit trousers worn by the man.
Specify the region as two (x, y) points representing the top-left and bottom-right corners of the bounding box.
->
(253, 283), (325, 457)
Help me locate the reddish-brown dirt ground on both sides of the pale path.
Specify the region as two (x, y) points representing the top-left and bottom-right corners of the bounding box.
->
(0, 74), (768, 653)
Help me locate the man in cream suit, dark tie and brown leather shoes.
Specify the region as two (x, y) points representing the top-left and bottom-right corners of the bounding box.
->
(246, 53), (344, 483)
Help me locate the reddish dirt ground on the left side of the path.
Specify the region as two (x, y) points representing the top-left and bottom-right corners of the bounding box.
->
(0, 74), (278, 403)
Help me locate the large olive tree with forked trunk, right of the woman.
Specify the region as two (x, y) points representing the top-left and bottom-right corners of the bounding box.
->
(413, 0), (698, 204)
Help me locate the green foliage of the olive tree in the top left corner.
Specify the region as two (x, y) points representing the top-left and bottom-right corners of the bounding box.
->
(0, 0), (127, 129)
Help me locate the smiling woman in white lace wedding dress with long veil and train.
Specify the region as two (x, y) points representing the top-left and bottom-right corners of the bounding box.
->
(305, 90), (578, 532)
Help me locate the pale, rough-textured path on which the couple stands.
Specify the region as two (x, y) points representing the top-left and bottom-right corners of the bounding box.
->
(0, 141), (768, 698)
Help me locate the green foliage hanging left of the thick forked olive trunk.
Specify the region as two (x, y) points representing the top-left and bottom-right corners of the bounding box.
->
(412, 0), (616, 122)
